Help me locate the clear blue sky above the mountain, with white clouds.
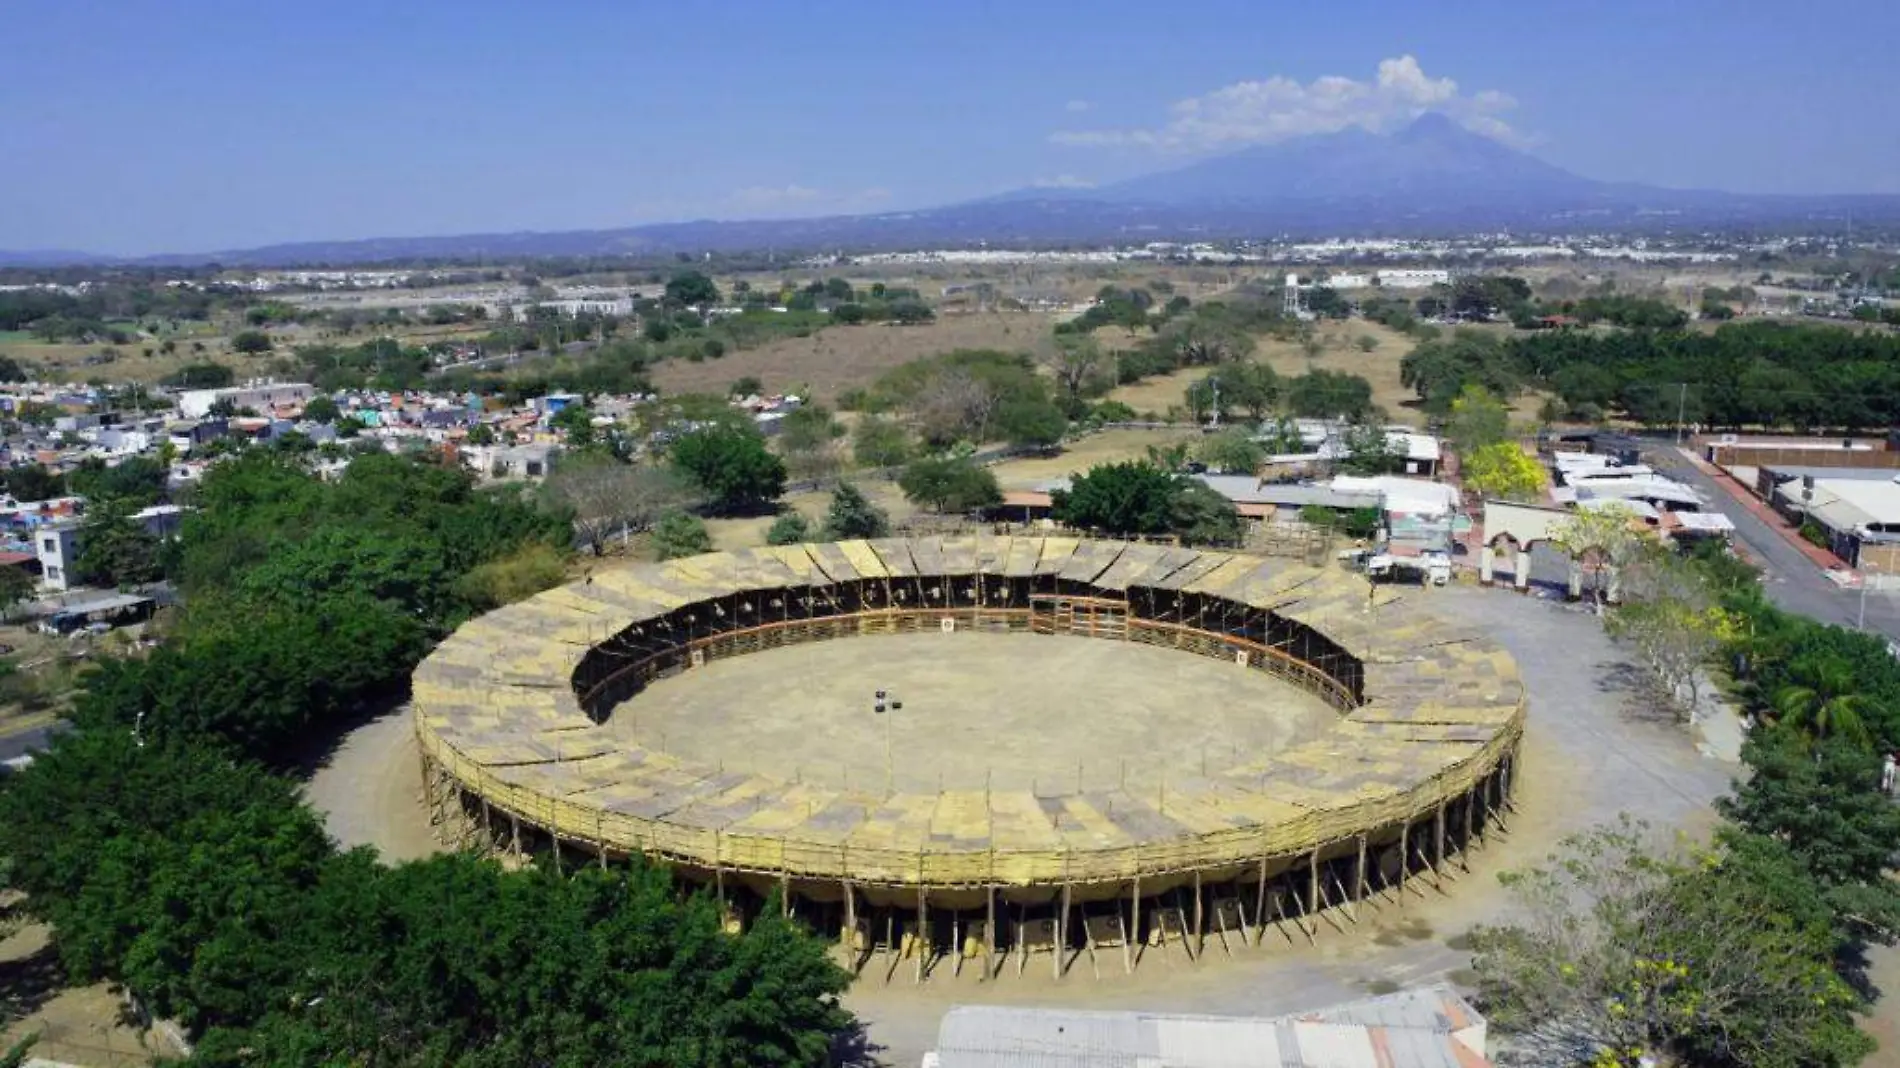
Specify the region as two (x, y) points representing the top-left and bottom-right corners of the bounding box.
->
(0, 0), (1900, 253)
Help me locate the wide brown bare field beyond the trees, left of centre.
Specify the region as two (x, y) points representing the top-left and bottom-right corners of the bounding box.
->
(654, 312), (1055, 405)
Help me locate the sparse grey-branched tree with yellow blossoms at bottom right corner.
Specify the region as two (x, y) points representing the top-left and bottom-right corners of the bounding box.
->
(1473, 825), (1872, 1066)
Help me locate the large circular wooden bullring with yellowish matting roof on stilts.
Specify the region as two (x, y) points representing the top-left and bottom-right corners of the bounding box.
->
(414, 538), (1524, 977)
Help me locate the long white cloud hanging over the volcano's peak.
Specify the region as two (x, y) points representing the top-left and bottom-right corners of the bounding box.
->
(1049, 55), (1518, 152)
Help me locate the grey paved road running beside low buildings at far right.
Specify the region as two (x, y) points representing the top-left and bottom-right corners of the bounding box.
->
(1644, 445), (1900, 642)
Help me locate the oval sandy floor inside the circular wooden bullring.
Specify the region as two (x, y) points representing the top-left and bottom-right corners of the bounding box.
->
(610, 633), (1334, 794)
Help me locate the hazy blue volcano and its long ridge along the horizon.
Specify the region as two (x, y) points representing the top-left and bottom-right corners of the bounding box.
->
(0, 114), (1900, 266)
